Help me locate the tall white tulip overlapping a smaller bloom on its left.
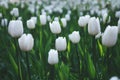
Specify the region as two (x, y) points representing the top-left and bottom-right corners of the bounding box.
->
(88, 17), (101, 35)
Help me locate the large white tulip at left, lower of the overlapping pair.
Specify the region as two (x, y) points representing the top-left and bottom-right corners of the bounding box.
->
(18, 34), (34, 51)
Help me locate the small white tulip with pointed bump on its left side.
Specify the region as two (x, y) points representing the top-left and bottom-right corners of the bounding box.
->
(68, 31), (80, 43)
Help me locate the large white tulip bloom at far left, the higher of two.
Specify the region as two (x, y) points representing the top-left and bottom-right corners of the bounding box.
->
(8, 20), (23, 37)
